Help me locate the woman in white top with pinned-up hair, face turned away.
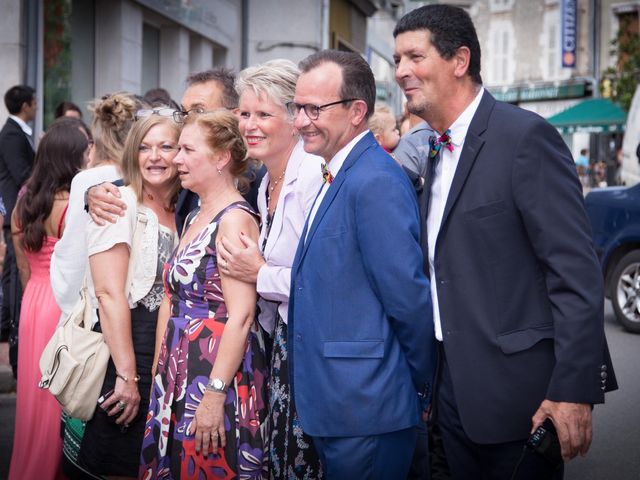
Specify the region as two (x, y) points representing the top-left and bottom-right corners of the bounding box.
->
(51, 92), (143, 480)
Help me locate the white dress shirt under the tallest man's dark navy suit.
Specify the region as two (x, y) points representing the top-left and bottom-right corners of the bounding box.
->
(427, 88), (484, 341)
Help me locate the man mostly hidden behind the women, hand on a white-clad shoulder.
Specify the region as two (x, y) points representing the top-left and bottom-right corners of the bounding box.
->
(88, 68), (265, 233)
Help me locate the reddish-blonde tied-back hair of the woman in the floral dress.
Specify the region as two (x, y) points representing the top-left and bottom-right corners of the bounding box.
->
(184, 110), (249, 192)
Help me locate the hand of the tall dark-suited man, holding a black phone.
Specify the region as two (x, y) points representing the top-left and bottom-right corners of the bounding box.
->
(531, 400), (592, 461)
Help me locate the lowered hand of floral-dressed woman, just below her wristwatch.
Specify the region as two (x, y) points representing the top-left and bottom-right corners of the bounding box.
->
(187, 390), (227, 454)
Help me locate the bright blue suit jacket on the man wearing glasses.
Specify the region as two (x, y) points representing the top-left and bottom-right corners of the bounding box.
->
(288, 133), (436, 436)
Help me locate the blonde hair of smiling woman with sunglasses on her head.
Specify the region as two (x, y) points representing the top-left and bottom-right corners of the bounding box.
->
(122, 115), (180, 207)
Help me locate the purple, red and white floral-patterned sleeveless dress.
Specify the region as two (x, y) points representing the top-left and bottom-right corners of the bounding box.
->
(139, 202), (267, 480)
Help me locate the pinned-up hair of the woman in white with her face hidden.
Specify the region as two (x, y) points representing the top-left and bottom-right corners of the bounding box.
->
(89, 92), (143, 165)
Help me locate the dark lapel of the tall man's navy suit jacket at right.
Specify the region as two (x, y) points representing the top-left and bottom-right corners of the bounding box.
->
(440, 91), (496, 231)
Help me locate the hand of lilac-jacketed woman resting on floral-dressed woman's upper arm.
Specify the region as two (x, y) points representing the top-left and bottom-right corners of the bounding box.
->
(217, 232), (266, 283)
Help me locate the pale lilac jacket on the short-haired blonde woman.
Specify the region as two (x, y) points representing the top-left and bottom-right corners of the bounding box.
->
(256, 141), (323, 333)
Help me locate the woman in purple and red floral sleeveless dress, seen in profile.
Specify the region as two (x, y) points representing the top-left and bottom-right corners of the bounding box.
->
(140, 111), (266, 480)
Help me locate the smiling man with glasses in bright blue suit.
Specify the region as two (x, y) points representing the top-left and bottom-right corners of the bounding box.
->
(288, 50), (436, 480)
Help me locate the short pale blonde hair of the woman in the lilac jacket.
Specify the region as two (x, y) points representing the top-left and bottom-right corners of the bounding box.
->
(236, 59), (300, 108)
